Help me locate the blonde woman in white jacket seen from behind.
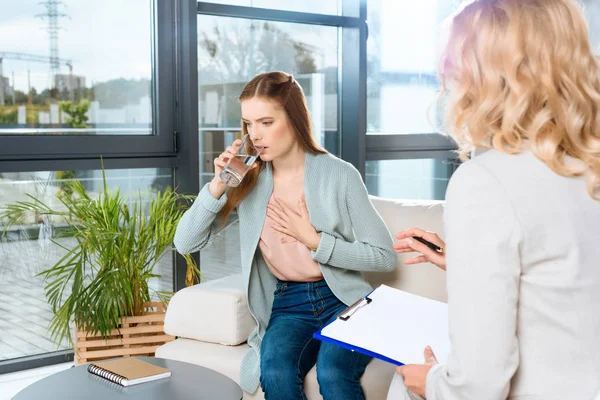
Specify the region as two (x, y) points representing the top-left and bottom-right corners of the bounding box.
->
(388, 0), (600, 400)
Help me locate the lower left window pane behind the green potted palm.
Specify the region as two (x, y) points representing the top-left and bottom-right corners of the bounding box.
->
(0, 169), (173, 360)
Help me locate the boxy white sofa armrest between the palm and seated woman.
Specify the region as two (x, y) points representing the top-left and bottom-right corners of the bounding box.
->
(165, 274), (256, 345)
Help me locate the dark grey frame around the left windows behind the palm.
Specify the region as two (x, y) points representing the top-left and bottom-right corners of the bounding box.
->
(0, 0), (185, 374)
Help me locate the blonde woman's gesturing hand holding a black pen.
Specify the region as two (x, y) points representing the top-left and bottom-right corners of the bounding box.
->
(394, 228), (446, 271)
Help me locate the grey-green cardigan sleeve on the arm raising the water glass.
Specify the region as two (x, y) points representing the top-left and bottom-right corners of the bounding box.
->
(173, 183), (227, 254)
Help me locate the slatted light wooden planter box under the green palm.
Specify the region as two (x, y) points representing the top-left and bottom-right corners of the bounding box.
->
(75, 302), (175, 365)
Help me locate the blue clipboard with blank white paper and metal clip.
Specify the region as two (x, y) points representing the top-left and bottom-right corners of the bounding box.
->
(313, 285), (450, 365)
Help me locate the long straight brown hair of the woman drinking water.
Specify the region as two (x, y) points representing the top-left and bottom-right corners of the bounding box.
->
(219, 71), (327, 224)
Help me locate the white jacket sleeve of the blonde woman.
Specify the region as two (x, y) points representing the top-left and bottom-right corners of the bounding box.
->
(426, 161), (522, 400)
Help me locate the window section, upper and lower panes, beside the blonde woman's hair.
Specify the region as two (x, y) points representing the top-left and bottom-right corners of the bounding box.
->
(365, 0), (458, 200)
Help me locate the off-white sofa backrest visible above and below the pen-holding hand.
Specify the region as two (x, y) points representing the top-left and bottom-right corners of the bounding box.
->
(365, 196), (447, 302)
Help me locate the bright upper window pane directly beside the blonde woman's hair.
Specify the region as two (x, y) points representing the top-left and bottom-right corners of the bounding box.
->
(367, 0), (456, 134)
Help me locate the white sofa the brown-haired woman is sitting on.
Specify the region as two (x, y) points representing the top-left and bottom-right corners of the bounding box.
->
(156, 197), (446, 400)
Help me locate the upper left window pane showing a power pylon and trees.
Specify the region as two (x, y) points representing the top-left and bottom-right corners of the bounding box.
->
(0, 0), (152, 135)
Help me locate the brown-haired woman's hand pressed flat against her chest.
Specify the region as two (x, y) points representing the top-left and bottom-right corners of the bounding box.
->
(267, 197), (321, 250)
